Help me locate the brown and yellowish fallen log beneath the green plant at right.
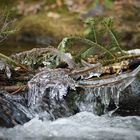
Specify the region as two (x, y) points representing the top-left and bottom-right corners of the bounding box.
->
(69, 58), (140, 79)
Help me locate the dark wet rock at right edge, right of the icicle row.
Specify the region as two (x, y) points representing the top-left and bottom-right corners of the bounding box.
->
(116, 77), (140, 116)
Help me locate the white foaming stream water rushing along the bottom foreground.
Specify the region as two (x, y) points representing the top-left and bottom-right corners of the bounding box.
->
(0, 112), (140, 140)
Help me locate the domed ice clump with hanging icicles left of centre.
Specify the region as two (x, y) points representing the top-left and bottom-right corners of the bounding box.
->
(28, 70), (75, 106)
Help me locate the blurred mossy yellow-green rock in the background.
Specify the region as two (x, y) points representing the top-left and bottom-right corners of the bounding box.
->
(16, 14), (83, 45)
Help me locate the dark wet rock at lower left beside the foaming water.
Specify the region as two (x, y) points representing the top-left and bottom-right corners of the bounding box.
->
(0, 92), (30, 127)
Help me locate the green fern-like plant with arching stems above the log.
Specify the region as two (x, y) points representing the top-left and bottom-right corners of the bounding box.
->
(58, 18), (124, 62)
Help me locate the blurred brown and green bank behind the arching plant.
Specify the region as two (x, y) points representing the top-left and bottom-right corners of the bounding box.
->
(0, 0), (140, 55)
